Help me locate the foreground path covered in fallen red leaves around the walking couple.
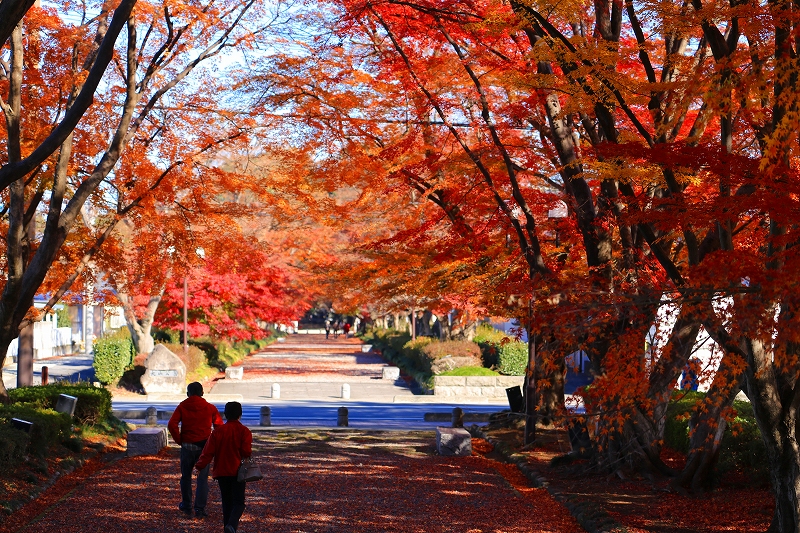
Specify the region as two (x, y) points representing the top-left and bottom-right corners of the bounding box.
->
(0, 430), (583, 533)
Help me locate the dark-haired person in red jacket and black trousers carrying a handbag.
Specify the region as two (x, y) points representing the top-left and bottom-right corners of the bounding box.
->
(194, 402), (253, 533)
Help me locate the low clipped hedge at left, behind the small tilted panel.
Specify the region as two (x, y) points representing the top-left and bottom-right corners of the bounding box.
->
(8, 383), (111, 425)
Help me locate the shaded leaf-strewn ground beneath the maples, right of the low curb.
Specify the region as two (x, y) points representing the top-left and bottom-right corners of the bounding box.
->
(485, 425), (774, 533)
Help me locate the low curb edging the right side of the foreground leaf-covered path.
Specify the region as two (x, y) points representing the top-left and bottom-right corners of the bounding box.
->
(467, 426), (630, 533)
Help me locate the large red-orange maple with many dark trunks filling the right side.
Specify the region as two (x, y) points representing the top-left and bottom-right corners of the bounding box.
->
(242, 1), (798, 531)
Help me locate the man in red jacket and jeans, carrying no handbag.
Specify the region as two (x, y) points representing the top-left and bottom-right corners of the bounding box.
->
(167, 381), (222, 518)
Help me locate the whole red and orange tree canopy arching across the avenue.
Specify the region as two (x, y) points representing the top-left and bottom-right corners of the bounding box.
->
(0, 0), (800, 533)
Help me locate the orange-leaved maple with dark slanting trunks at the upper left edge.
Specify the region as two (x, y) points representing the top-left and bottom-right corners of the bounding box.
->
(0, 1), (272, 396)
